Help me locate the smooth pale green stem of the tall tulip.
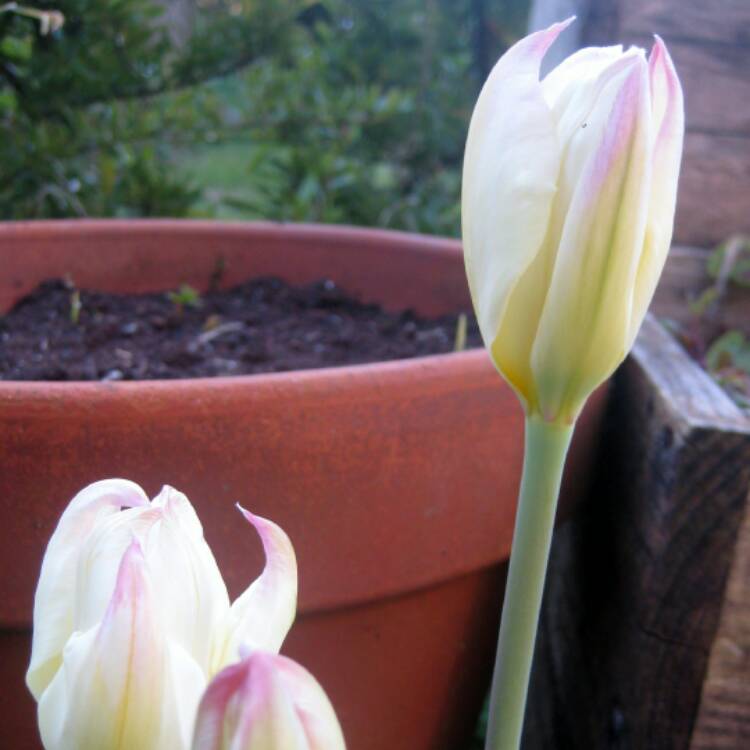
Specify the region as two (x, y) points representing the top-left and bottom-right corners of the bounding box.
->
(485, 415), (575, 750)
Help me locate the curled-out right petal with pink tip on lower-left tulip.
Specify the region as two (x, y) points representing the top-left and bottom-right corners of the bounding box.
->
(221, 506), (297, 666)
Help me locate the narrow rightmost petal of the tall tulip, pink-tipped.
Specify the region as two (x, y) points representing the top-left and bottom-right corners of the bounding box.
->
(627, 36), (685, 349)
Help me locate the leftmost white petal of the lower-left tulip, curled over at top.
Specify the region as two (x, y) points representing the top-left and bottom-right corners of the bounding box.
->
(26, 479), (148, 700)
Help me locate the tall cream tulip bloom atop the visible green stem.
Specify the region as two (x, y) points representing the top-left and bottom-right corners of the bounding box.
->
(462, 21), (684, 423)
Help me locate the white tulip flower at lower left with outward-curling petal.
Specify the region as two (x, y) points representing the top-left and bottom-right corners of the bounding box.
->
(26, 479), (297, 750)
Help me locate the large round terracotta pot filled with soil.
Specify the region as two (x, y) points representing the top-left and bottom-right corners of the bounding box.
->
(0, 221), (604, 750)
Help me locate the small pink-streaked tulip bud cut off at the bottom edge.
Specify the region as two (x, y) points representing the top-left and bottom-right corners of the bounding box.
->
(192, 651), (345, 750)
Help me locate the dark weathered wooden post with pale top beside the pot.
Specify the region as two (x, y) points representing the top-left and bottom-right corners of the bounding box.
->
(525, 319), (750, 750)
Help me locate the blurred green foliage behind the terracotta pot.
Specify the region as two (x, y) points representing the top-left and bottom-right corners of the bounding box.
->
(0, 0), (527, 234)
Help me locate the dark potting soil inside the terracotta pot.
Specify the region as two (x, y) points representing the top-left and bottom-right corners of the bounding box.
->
(0, 278), (481, 380)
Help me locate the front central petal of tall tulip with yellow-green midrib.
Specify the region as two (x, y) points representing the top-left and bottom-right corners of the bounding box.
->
(531, 53), (652, 421)
